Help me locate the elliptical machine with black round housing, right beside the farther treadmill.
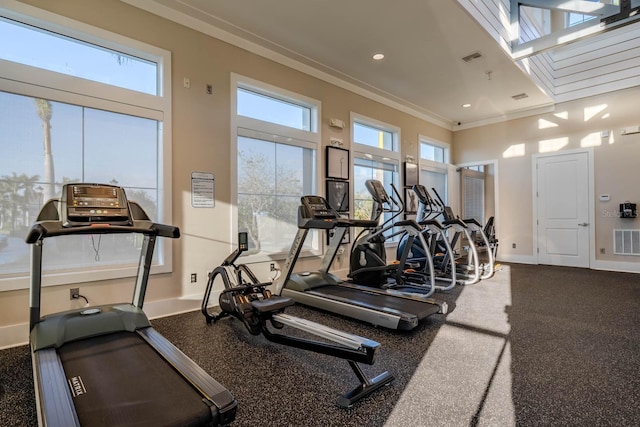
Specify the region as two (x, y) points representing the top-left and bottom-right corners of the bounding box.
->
(348, 179), (436, 297)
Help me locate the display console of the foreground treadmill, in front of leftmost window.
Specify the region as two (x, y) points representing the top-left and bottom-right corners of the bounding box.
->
(60, 184), (133, 227)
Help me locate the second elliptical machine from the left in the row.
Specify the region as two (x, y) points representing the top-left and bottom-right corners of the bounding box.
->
(398, 184), (458, 291)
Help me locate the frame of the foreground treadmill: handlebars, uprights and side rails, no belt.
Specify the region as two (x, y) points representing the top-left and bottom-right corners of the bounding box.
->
(26, 191), (238, 427)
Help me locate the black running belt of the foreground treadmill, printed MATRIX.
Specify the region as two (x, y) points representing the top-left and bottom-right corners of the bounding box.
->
(58, 332), (211, 427)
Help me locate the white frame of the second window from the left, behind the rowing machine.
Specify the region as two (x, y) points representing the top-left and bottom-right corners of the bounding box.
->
(229, 73), (324, 264)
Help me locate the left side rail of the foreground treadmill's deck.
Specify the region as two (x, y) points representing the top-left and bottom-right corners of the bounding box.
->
(31, 348), (80, 427)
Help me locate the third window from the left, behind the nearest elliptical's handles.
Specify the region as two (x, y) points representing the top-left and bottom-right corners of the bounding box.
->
(351, 114), (402, 239)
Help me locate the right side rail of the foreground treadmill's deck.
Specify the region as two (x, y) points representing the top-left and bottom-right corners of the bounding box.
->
(137, 327), (238, 425)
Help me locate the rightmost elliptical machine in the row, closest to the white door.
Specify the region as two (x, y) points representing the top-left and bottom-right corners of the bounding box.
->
(431, 188), (495, 284)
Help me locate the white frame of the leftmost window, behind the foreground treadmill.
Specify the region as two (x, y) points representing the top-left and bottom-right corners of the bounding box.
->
(0, 3), (173, 291)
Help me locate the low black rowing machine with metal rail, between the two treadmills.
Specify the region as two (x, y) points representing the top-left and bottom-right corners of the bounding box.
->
(201, 232), (394, 408)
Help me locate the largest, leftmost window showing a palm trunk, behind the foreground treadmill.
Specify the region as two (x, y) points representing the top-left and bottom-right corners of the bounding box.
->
(0, 5), (171, 290)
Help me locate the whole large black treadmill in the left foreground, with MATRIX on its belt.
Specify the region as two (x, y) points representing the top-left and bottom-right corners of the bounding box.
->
(26, 183), (237, 427)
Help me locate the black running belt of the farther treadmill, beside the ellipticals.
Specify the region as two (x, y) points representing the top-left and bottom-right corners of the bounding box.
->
(309, 285), (440, 320)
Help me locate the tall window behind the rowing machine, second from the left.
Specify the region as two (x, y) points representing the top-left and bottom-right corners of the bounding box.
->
(233, 75), (321, 261)
